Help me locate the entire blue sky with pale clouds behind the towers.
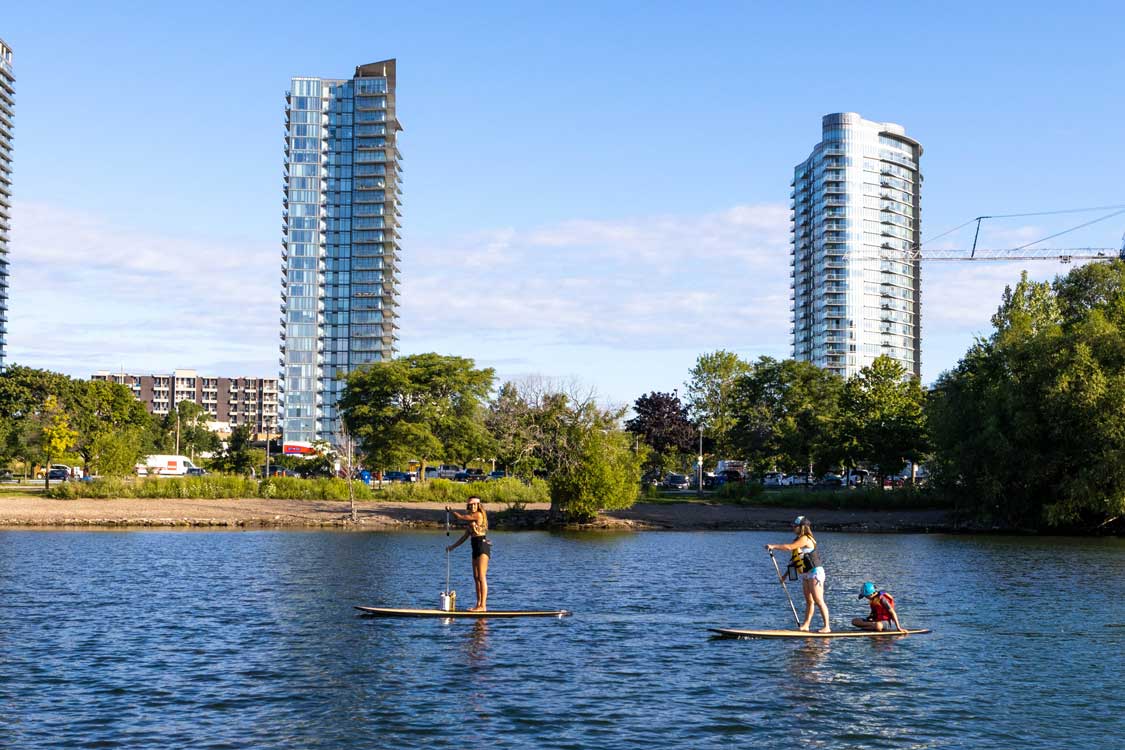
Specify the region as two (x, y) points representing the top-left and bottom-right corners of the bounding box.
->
(0, 0), (1125, 404)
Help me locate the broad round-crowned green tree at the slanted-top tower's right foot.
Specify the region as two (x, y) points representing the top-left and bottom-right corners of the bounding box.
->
(340, 353), (494, 479)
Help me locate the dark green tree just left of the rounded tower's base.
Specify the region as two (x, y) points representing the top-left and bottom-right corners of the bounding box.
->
(730, 356), (844, 473)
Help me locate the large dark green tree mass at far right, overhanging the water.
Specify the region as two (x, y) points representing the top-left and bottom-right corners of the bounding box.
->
(927, 261), (1125, 527)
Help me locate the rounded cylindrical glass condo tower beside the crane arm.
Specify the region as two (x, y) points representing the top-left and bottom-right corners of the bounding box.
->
(791, 112), (921, 377)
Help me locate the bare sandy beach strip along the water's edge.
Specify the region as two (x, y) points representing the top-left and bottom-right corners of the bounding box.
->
(0, 496), (954, 532)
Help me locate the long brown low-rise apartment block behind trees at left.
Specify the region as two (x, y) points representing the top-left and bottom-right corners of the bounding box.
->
(90, 370), (278, 440)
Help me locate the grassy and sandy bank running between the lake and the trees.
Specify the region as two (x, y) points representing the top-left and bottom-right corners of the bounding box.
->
(0, 477), (1108, 534)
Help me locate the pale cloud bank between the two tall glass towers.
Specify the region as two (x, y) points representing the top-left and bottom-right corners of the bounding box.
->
(402, 205), (789, 351)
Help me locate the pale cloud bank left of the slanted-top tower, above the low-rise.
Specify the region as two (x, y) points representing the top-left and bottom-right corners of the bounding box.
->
(8, 204), (280, 376)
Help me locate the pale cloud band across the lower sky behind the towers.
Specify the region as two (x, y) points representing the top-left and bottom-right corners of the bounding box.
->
(8, 204), (1089, 395)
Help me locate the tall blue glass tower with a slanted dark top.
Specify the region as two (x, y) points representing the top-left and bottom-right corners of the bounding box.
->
(280, 60), (402, 444)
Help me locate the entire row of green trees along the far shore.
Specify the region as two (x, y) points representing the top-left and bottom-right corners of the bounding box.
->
(0, 261), (1125, 528)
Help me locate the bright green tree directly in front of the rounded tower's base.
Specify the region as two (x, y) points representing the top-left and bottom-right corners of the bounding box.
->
(837, 356), (926, 479)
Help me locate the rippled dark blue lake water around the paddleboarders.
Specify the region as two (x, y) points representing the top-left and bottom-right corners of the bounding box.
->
(0, 531), (1125, 750)
